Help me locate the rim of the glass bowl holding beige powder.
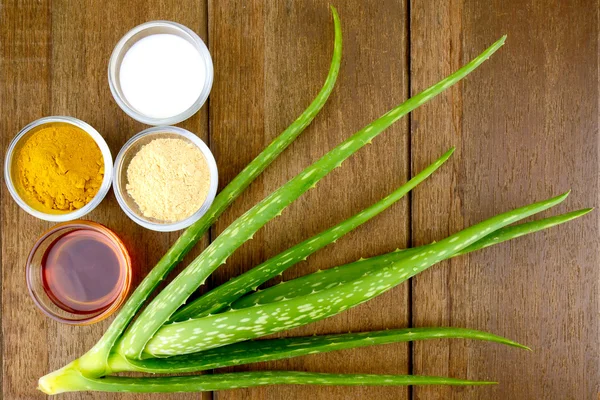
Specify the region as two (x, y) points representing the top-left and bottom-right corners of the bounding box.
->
(113, 126), (219, 232)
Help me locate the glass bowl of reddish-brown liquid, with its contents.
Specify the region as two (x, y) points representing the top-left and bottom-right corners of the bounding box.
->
(26, 221), (131, 325)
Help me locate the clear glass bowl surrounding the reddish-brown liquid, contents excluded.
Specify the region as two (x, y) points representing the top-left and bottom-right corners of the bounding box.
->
(26, 221), (131, 325)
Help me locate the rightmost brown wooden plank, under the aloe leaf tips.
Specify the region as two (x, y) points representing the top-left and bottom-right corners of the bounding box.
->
(410, 0), (600, 399)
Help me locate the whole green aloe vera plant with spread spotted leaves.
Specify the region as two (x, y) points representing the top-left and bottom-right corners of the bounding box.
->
(39, 7), (589, 394)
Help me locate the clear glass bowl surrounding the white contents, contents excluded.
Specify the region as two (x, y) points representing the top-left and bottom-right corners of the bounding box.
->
(108, 21), (214, 126)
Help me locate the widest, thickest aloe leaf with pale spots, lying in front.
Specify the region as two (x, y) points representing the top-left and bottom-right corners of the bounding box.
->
(144, 192), (568, 358)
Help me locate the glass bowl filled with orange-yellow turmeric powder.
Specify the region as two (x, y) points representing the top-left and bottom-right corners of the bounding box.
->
(4, 116), (113, 222)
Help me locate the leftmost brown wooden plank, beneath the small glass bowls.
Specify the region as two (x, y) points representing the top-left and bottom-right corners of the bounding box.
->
(0, 0), (211, 400)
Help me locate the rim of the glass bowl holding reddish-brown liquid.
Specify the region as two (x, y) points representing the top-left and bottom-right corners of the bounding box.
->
(25, 220), (132, 325)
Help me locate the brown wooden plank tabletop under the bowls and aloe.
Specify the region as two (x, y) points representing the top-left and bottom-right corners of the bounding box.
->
(0, 0), (600, 400)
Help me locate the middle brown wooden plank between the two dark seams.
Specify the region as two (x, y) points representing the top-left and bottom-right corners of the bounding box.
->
(209, 0), (408, 400)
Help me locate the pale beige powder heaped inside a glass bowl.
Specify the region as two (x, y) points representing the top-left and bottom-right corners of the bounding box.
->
(126, 139), (210, 222)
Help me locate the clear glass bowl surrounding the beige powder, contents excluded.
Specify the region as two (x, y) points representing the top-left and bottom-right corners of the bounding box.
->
(113, 126), (219, 232)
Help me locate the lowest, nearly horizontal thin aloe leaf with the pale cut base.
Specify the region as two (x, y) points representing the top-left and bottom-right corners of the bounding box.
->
(39, 371), (496, 394)
